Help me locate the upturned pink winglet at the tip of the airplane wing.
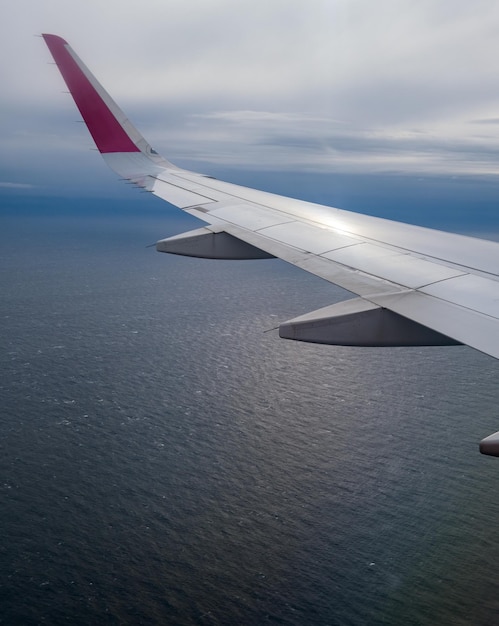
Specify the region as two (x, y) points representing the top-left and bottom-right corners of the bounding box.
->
(43, 35), (140, 153)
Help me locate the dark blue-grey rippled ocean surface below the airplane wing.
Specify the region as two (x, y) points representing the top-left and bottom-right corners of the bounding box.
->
(0, 193), (499, 626)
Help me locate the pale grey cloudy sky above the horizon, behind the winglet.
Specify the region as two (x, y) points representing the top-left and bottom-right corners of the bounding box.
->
(0, 0), (499, 202)
